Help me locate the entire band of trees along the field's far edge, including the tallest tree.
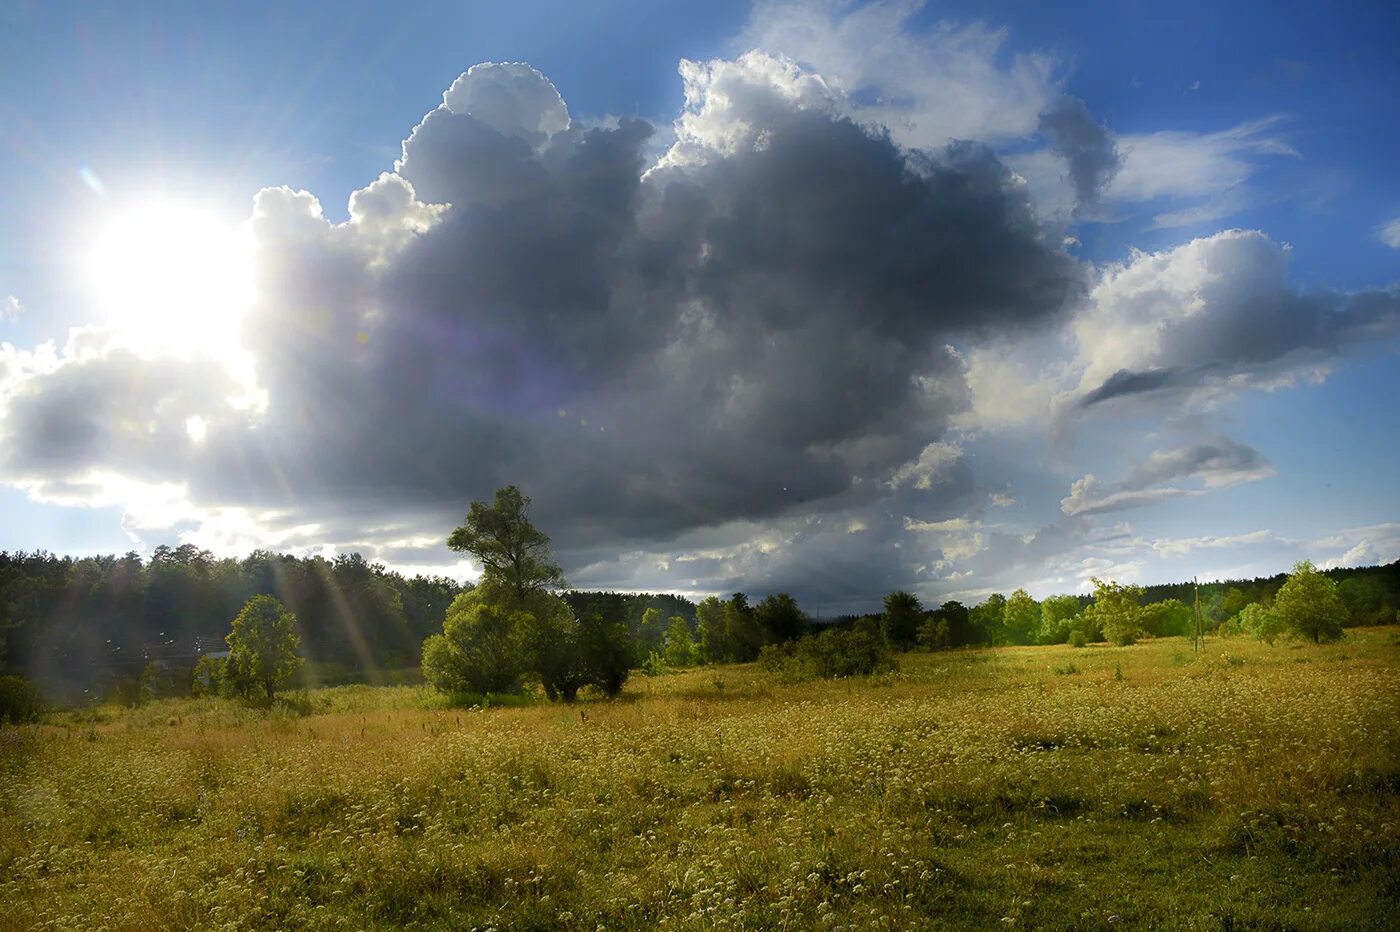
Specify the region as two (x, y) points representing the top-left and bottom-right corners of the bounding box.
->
(0, 487), (1400, 701)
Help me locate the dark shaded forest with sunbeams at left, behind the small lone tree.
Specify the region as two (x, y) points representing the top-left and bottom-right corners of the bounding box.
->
(0, 544), (462, 702)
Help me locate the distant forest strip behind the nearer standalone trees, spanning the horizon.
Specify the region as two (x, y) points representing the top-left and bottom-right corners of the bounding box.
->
(0, 490), (1400, 705)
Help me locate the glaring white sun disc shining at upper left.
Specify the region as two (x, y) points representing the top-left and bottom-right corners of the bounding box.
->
(83, 200), (252, 350)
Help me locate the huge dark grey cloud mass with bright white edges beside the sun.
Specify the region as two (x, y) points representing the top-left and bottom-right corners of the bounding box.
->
(7, 59), (1084, 591)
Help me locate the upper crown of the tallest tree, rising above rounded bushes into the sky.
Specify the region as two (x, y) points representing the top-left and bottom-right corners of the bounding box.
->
(447, 486), (566, 599)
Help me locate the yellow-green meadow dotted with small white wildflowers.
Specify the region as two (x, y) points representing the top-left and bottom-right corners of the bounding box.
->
(0, 628), (1400, 929)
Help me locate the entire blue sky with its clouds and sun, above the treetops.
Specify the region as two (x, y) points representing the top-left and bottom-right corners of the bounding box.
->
(0, 0), (1400, 614)
